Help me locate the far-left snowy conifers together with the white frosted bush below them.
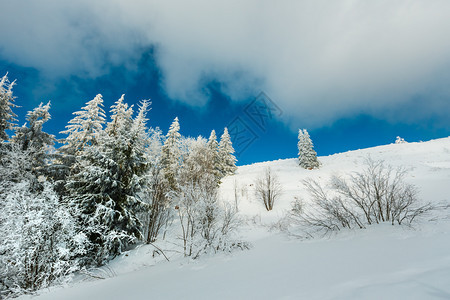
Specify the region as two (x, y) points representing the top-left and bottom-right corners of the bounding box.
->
(0, 76), (87, 297)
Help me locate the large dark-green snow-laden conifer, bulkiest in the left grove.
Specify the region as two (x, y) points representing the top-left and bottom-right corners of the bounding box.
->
(66, 97), (149, 264)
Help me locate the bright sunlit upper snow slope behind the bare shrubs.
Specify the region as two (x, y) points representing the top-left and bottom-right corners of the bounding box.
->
(221, 138), (450, 223)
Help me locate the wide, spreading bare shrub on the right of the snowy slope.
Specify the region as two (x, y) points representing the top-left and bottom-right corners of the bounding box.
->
(289, 159), (433, 235)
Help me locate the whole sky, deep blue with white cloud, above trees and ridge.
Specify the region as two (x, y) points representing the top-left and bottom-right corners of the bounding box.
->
(0, 0), (450, 164)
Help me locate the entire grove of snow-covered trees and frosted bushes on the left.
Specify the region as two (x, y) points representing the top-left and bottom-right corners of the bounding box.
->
(0, 75), (236, 298)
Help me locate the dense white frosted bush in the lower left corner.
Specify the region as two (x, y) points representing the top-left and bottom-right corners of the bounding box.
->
(0, 181), (89, 298)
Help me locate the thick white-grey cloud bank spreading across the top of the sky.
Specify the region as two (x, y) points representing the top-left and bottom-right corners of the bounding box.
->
(0, 0), (450, 126)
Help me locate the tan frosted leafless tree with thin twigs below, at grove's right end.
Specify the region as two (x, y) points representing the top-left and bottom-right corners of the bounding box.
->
(174, 132), (247, 258)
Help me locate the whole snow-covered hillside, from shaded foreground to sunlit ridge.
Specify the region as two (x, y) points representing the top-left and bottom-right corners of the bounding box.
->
(20, 137), (450, 300)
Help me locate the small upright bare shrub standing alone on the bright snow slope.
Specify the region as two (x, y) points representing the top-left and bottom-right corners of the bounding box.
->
(255, 167), (283, 211)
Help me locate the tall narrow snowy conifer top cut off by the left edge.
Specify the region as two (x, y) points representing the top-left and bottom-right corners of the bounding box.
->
(0, 74), (17, 140)
